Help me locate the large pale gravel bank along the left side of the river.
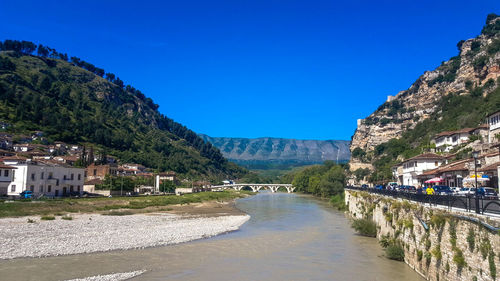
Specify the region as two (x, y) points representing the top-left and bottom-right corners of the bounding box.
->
(0, 213), (250, 259)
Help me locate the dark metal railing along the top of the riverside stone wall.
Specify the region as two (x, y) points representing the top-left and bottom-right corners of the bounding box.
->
(346, 186), (500, 215)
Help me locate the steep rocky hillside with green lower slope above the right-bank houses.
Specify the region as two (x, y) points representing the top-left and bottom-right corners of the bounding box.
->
(351, 14), (500, 182)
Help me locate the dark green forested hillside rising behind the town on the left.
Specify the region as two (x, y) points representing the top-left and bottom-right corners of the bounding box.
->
(0, 40), (244, 178)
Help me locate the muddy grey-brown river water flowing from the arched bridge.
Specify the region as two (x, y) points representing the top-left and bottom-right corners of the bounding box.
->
(0, 193), (423, 281)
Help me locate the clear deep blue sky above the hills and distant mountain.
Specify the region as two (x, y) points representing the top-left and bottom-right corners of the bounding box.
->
(0, 0), (500, 140)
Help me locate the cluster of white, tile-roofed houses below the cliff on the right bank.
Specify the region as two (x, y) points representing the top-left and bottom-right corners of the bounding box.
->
(392, 111), (500, 190)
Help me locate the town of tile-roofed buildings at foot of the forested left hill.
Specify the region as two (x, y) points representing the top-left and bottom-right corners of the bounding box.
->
(0, 129), (188, 197)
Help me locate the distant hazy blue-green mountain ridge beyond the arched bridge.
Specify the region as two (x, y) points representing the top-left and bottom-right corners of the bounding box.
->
(199, 135), (350, 168)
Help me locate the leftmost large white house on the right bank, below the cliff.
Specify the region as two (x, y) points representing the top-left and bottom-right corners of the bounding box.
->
(397, 153), (446, 186)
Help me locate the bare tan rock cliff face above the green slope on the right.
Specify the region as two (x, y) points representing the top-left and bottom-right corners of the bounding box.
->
(350, 14), (500, 168)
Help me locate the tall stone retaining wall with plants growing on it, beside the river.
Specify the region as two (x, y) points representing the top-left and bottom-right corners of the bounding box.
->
(345, 190), (500, 281)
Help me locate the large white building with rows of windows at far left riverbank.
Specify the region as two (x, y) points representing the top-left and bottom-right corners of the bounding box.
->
(3, 157), (85, 196)
